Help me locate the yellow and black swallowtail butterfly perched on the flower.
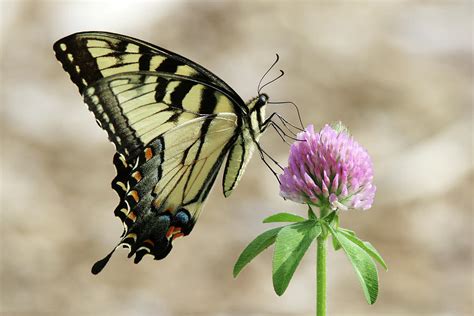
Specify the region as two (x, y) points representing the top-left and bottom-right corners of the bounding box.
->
(53, 32), (271, 274)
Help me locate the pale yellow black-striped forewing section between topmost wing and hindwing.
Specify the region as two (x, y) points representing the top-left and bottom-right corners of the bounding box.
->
(84, 71), (242, 160)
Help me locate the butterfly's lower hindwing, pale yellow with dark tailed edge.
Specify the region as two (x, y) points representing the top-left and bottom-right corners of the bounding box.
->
(93, 113), (238, 273)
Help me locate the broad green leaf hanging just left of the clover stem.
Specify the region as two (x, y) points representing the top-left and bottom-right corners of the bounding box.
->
(273, 220), (321, 295)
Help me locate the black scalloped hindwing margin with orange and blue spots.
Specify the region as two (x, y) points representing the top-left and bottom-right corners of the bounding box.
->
(108, 137), (187, 264)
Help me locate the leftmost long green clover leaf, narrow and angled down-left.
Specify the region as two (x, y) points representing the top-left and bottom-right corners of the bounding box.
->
(233, 226), (285, 278)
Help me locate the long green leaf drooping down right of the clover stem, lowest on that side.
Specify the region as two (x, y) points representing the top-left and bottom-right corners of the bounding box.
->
(327, 225), (379, 305)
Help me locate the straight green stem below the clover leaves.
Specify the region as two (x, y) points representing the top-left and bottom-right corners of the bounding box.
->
(316, 234), (327, 316)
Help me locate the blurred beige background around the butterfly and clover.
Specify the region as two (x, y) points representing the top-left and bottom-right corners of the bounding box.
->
(0, 0), (474, 315)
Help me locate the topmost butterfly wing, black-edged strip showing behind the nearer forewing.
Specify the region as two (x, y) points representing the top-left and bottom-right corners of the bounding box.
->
(53, 32), (244, 104)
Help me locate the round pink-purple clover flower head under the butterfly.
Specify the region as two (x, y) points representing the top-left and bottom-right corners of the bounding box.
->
(280, 125), (376, 210)
